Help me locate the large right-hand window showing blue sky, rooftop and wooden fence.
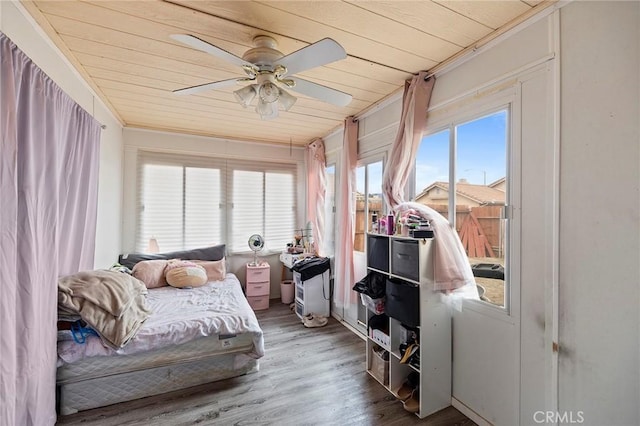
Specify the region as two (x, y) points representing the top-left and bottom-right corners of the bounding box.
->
(414, 109), (509, 307)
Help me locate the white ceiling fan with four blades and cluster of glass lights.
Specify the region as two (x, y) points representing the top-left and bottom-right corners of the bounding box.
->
(171, 34), (352, 120)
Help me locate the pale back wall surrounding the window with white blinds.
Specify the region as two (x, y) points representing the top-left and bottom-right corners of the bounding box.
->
(122, 128), (306, 298)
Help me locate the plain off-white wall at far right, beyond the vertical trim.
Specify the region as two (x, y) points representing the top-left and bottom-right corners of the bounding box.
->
(559, 1), (640, 425)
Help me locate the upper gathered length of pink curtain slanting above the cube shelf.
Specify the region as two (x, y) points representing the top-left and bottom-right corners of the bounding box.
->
(382, 71), (436, 209)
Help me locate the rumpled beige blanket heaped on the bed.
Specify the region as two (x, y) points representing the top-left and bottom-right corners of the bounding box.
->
(58, 271), (151, 349)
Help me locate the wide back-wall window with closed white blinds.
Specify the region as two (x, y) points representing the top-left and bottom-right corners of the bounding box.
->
(136, 152), (296, 252)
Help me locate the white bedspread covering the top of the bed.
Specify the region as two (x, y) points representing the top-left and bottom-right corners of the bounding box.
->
(58, 274), (264, 364)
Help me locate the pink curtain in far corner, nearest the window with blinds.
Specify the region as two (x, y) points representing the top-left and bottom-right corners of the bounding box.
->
(307, 139), (327, 256)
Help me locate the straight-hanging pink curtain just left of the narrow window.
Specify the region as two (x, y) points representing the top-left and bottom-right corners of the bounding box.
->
(334, 117), (358, 308)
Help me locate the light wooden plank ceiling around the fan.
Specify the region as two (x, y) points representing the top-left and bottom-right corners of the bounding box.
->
(23, 0), (550, 145)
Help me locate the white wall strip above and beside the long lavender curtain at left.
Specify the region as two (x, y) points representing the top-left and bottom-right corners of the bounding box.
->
(0, 0), (122, 268)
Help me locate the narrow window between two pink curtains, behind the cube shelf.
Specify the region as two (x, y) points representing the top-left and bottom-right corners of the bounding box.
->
(353, 160), (383, 252)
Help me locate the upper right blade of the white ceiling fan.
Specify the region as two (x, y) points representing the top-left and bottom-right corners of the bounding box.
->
(277, 38), (347, 75)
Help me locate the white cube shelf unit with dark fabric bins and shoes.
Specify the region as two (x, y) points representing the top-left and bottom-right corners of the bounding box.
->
(367, 234), (451, 418)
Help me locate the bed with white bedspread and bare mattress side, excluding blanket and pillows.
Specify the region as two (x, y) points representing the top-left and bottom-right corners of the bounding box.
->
(57, 273), (264, 415)
